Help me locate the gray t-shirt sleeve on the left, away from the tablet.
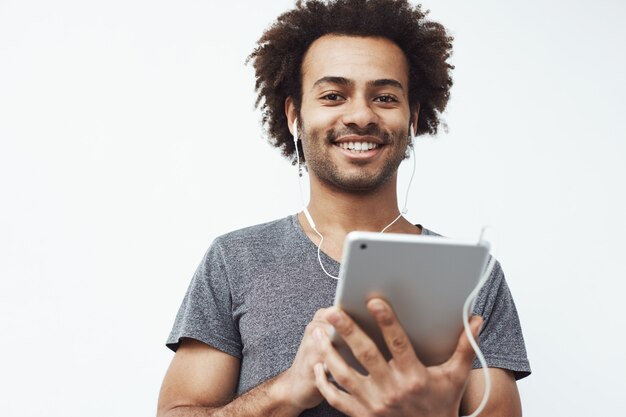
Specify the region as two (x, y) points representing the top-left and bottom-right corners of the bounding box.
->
(166, 242), (242, 358)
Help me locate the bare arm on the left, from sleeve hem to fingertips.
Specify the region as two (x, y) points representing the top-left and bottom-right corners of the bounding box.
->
(157, 309), (328, 417)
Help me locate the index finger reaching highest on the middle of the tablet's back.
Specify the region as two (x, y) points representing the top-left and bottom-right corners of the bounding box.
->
(367, 298), (426, 372)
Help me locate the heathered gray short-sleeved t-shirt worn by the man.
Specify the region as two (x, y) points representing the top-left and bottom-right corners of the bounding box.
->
(167, 215), (530, 416)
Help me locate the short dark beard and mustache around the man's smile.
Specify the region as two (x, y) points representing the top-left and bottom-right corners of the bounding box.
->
(301, 122), (408, 193)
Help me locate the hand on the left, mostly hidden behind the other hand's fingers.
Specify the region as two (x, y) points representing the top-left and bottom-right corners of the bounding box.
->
(277, 308), (329, 410)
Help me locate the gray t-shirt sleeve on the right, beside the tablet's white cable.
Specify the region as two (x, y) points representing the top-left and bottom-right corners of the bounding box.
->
(473, 262), (531, 379)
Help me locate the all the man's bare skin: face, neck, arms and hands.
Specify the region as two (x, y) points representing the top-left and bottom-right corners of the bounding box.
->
(158, 36), (521, 417)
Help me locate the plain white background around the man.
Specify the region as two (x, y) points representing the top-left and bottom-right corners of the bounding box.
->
(0, 0), (626, 417)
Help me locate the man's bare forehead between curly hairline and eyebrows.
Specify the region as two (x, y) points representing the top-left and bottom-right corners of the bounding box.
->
(302, 35), (408, 92)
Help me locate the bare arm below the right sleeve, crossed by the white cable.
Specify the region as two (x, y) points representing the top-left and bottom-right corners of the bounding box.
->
(461, 368), (522, 417)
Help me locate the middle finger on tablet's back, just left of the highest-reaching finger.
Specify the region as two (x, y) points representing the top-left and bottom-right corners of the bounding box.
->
(326, 308), (389, 377)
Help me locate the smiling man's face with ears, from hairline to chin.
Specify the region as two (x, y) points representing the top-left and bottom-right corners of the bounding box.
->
(287, 35), (418, 193)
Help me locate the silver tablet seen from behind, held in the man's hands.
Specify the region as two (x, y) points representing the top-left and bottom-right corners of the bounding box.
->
(332, 232), (489, 374)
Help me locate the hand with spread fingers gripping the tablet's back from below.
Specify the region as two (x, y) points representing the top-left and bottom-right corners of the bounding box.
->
(314, 299), (482, 417)
